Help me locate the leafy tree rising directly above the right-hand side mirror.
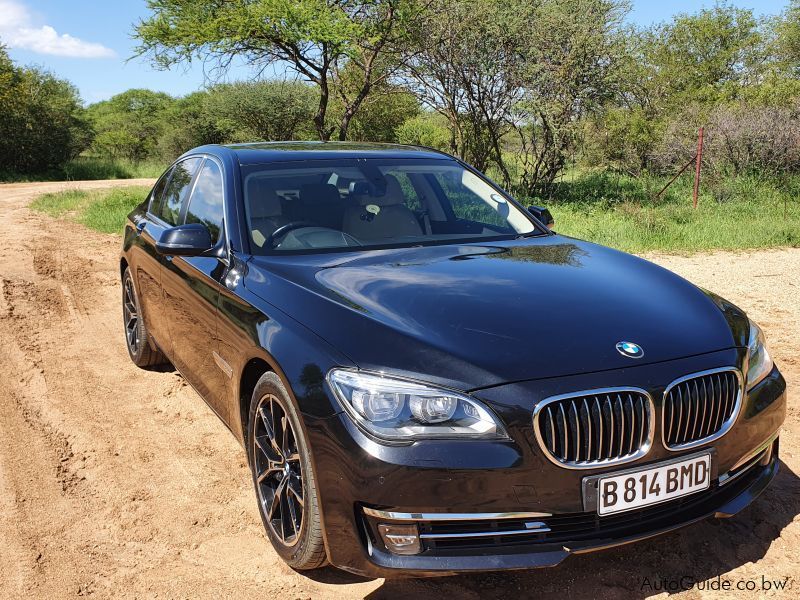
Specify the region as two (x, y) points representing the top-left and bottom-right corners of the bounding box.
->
(514, 0), (626, 194)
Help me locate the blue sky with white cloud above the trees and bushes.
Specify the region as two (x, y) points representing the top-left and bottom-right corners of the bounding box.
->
(0, 0), (788, 103)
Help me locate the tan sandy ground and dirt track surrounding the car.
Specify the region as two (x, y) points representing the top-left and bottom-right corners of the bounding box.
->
(0, 181), (800, 600)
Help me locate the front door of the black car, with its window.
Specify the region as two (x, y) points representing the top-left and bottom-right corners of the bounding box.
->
(161, 158), (230, 419)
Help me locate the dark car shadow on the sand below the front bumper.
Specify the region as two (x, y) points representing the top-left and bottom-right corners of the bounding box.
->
(360, 461), (800, 600)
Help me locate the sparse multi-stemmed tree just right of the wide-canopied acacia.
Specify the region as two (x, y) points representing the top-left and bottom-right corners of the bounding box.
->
(403, 0), (535, 186)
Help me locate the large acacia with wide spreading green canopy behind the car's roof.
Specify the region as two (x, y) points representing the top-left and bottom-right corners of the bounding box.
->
(134, 0), (414, 140)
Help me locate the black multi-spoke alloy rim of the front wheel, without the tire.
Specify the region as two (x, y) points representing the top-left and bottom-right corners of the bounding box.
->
(253, 394), (305, 546)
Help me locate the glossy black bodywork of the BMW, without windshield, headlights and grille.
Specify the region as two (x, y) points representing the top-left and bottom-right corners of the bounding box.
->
(121, 143), (786, 576)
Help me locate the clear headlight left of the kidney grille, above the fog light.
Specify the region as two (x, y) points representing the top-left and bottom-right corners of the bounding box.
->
(328, 369), (508, 442)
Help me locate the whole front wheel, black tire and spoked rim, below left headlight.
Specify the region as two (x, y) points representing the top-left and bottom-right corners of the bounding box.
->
(247, 372), (327, 571)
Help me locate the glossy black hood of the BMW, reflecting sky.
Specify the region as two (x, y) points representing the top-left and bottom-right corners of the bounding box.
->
(245, 235), (746, 389)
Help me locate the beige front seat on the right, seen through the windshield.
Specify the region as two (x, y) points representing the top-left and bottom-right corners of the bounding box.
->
(342, 175), (422, 242)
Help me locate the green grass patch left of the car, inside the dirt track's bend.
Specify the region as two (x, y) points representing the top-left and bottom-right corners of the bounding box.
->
(31, 186), (150, 233)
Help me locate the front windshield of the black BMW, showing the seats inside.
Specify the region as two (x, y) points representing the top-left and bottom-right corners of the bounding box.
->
(242, 159), (538, 254)
